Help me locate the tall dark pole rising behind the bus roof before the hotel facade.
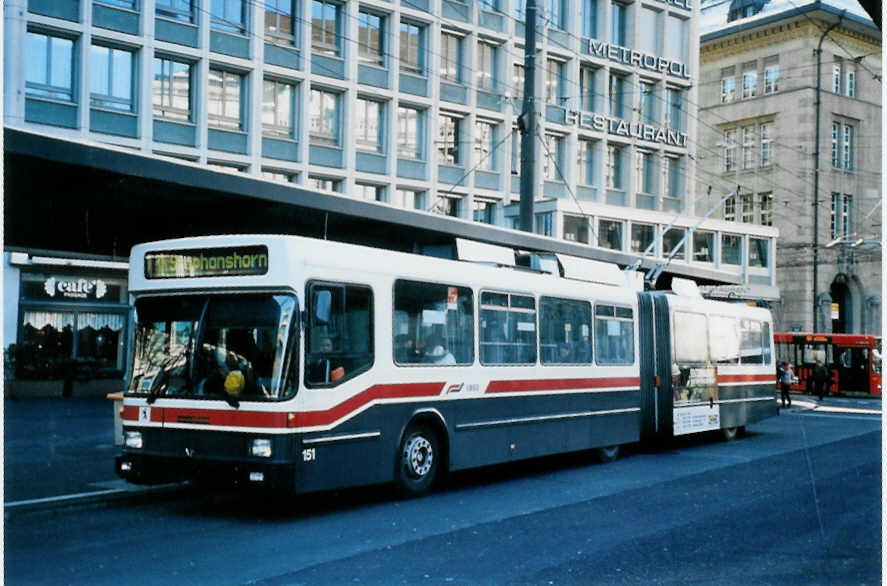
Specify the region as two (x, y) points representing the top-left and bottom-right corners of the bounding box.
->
(517, 0), (539, 232)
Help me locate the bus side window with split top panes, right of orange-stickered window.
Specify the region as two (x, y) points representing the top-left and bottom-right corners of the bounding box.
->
(480, 291), (536, 364)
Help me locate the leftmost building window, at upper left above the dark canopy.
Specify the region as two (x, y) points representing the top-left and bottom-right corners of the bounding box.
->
(25, 31), (74, 102)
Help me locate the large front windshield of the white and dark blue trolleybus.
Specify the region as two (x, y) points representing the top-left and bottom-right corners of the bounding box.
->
(128, 294), (299, 404)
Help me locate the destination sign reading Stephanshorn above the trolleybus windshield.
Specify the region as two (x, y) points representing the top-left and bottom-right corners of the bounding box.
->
(145, 246), (268, 279)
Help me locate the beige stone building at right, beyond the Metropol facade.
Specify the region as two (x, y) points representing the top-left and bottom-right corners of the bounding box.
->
(697, 0), (883, 333)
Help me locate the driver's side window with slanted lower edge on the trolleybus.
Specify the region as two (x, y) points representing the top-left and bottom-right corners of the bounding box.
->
(305, 283), (373, 387)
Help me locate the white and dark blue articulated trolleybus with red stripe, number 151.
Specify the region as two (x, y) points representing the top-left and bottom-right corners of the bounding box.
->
(116, 236), (777, 494)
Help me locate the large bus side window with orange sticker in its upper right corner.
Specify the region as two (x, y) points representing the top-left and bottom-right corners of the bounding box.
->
(393, 280), (474, 365)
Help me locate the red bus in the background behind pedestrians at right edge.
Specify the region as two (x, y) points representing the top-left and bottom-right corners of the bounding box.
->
(773, 332), (881, 395)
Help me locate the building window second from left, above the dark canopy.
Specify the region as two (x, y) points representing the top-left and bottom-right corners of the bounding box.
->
(89, 45), (135, 112)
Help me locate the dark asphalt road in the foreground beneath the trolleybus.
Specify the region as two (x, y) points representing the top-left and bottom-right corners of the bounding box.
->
(5, 406), (881, 585)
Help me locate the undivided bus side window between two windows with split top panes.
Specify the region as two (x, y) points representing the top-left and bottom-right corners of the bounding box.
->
(539, 297), (591, 364)
